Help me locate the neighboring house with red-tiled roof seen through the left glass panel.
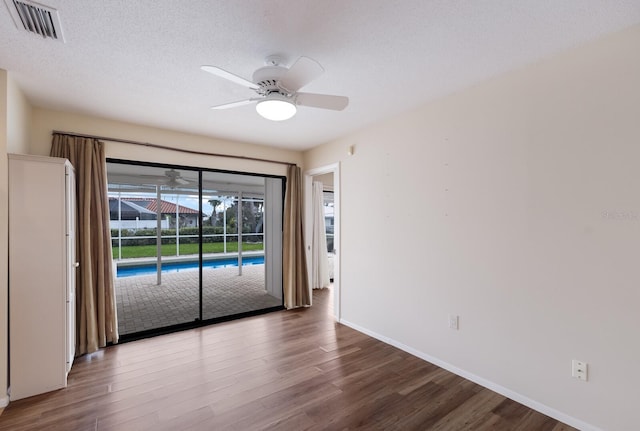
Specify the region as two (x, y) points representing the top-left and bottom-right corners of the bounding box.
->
(109, 197), (200, 229)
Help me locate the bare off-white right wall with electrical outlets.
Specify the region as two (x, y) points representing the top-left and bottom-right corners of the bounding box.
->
(305, 26), (640, 430)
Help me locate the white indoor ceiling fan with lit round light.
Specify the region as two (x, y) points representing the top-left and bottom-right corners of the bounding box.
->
(201, 55), (349, 121)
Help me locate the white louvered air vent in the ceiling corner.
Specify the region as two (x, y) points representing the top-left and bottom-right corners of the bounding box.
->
(4, 0), (64, 42)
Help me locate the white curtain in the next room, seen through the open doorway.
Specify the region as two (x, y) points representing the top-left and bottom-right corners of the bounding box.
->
(311, 181), (330, 289)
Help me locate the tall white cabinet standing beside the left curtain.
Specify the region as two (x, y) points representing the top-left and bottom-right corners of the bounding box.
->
(8, 154), (76, 400)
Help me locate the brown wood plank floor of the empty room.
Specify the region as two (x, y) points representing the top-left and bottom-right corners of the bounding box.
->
(0, 290), (573, 431)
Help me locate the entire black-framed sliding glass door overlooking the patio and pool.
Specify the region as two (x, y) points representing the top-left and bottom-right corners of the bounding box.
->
(107, 161), (283, 339)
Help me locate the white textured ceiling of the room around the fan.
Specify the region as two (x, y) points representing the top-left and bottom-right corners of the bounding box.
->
(0, 0), (640, 150)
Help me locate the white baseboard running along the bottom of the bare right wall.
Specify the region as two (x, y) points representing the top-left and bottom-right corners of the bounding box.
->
(340, 319), (602, 431)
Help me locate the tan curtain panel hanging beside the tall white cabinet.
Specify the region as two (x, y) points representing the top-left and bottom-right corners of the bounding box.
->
(51, 133), (118, 355)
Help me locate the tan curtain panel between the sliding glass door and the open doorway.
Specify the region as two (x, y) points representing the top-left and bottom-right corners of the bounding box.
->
(282, 166), (311, 308)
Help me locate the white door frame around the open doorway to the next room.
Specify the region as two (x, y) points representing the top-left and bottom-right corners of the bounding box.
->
(304, 162), (342, 322)
